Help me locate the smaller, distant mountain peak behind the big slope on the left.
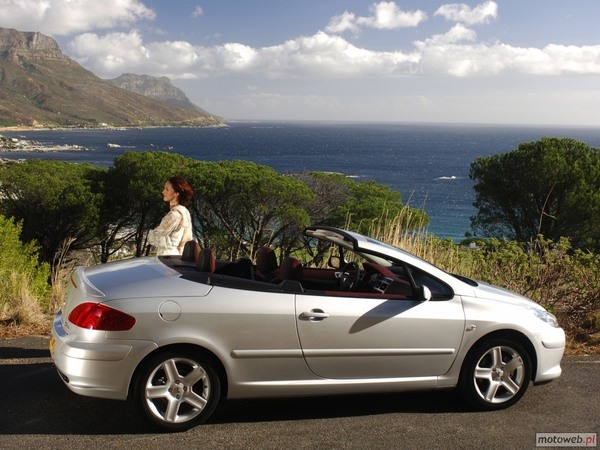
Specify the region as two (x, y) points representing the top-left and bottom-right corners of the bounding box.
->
(106, 73), (206, 112)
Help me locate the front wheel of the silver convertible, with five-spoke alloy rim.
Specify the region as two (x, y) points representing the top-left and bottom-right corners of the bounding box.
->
(459, 339), (532, 411)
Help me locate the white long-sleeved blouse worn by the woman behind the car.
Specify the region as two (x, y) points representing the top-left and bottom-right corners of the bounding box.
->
(148, 205), (192, 256)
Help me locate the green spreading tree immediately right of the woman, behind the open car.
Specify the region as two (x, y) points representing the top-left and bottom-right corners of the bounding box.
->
(188, 161), (312, 257)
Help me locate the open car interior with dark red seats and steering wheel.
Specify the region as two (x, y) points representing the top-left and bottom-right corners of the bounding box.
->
(159, 241), (452, 300)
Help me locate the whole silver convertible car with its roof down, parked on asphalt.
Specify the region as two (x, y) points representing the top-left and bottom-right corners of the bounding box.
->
(50, 226), (565, 431)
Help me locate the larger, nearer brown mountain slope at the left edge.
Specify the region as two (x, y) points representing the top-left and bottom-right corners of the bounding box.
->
(0, 28), (223, 127)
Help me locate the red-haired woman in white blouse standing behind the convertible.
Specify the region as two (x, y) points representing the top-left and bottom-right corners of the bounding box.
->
(148, 176), (194, 256)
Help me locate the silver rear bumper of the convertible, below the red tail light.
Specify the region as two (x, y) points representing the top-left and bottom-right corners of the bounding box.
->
(50, 311), (157, 400)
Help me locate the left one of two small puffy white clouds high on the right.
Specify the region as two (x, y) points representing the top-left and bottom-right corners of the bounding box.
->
(325, 1), (427, 34)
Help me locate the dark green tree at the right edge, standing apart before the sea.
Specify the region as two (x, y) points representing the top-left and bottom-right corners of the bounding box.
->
(470, 138), (600, 250)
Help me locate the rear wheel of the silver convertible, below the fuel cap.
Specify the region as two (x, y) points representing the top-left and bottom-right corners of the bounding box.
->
(132, 351), (221, 431)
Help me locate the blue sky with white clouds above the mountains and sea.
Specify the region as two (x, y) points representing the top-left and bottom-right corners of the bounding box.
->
(0, 0), (600, 127)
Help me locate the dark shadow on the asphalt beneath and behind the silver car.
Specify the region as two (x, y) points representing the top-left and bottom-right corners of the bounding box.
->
(0, 347), (467, 435)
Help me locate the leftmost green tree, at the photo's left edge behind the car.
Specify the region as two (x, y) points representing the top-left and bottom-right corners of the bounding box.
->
(0, 160), (104, 267)
